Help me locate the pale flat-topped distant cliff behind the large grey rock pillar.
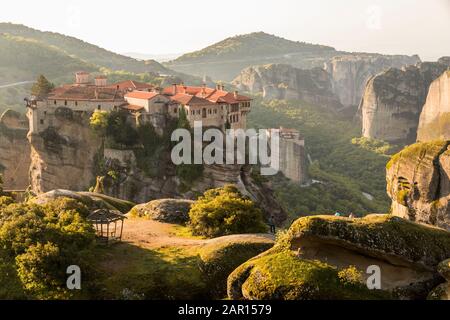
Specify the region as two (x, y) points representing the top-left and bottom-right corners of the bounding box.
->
(325, 54), (420, 106)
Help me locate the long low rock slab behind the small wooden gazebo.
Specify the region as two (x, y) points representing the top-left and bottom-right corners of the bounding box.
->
(30, 189), (135, 213)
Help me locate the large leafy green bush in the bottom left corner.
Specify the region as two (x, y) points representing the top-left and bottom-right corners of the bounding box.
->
(0, 198), (95, 299)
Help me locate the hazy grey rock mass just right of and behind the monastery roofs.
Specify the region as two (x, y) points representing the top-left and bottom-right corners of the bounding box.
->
(232, 64), (340, 108)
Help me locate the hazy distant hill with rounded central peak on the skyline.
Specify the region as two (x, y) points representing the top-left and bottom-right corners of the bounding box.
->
(165, 32), (342, 81)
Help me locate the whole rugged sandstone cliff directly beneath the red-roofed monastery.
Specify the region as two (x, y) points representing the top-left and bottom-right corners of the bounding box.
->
(29, 112), (286, 223)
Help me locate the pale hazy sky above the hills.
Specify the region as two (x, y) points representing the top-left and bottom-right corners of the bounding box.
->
(0, 0), (450, 59)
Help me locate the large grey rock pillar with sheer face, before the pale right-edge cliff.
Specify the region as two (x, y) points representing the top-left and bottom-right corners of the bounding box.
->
(359, 62), (448, 144)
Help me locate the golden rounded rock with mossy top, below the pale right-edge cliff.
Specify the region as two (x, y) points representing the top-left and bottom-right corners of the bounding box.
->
(386, 141), (450, 230)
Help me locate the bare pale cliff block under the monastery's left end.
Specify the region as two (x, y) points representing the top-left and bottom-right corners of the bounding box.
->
(28, 113), (101, 193)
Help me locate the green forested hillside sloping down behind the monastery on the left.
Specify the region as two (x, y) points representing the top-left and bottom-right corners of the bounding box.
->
(0, 23), (201, 112)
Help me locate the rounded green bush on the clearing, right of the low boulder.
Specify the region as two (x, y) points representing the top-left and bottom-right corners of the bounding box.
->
(189, 185), (267, 237)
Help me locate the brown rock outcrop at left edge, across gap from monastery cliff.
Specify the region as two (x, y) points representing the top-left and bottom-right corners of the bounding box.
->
(0, 110), (31, 190)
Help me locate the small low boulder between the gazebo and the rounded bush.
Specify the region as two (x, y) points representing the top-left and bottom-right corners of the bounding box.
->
(129, 199), (194, 224)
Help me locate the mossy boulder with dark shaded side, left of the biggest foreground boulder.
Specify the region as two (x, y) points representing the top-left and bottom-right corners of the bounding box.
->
(199, 235), (274, 298)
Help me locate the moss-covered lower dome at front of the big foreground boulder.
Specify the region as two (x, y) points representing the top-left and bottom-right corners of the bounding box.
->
(230, 251), (387, 300)
